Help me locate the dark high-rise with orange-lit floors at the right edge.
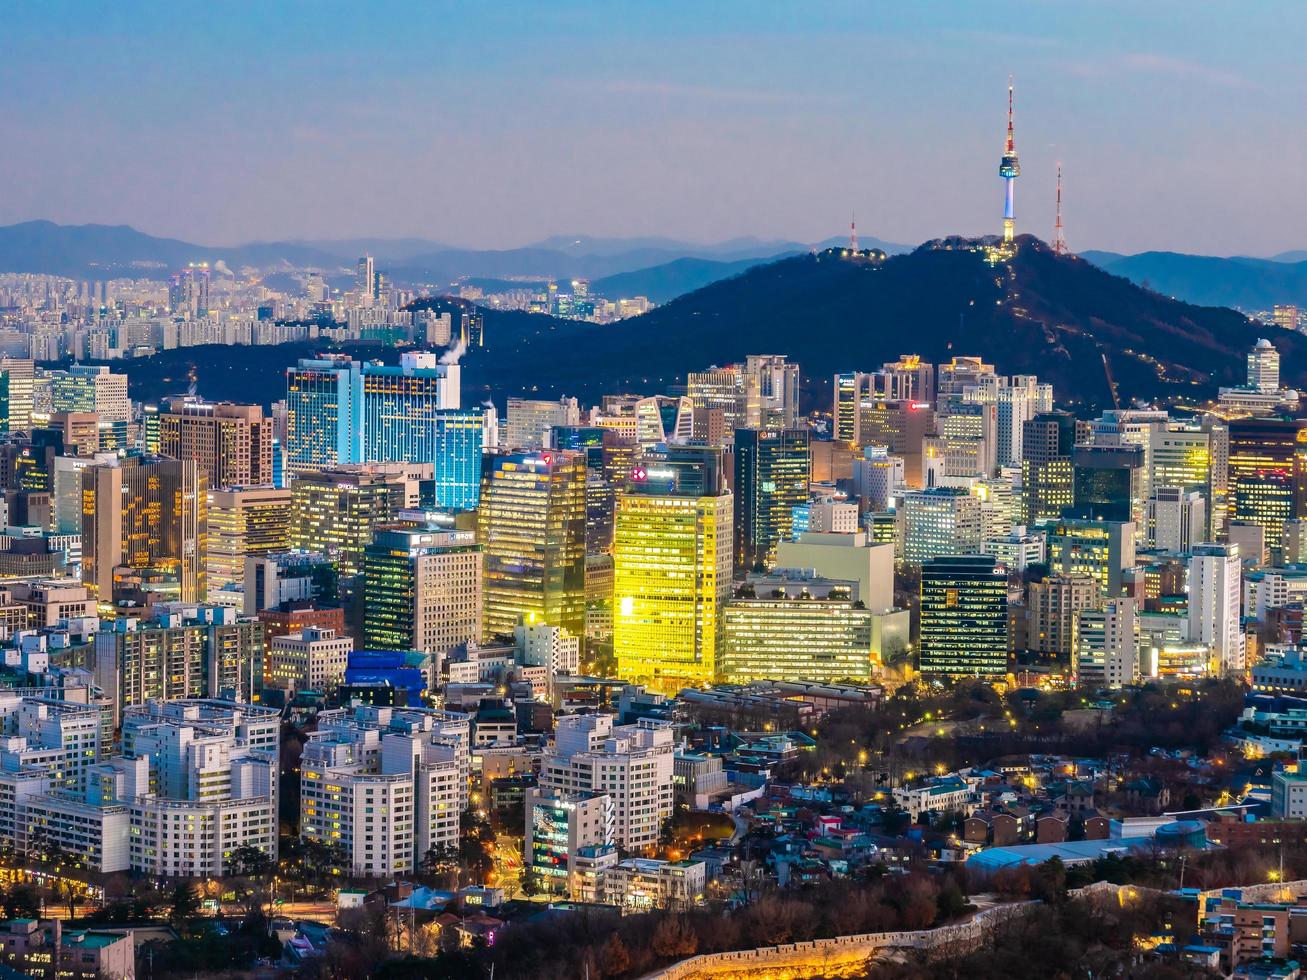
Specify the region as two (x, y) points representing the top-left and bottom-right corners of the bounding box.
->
(1229, 418), (1307, 541)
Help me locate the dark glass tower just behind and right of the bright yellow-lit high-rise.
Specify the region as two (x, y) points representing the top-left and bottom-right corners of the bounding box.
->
(735, 429), (812, 571)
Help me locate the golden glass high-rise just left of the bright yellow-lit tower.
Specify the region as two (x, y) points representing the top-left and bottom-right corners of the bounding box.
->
(477, 449), (586, 639)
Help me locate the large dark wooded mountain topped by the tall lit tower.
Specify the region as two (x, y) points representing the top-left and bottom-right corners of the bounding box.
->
(441, 237), (1307, 408)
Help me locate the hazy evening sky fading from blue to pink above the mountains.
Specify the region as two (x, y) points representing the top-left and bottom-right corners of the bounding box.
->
(0, 0), (1307, 255)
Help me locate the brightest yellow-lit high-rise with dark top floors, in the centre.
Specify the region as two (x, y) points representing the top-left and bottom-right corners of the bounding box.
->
(613, 447), (735, 691)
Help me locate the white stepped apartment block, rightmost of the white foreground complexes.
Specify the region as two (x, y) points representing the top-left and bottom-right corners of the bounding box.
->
(538, 715), (676, 851)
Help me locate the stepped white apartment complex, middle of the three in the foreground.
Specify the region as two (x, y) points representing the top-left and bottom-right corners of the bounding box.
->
(299, 706), (469, 878)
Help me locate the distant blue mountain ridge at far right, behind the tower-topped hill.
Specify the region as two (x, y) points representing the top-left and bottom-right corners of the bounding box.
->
(1081, 252), (1307, 311)
